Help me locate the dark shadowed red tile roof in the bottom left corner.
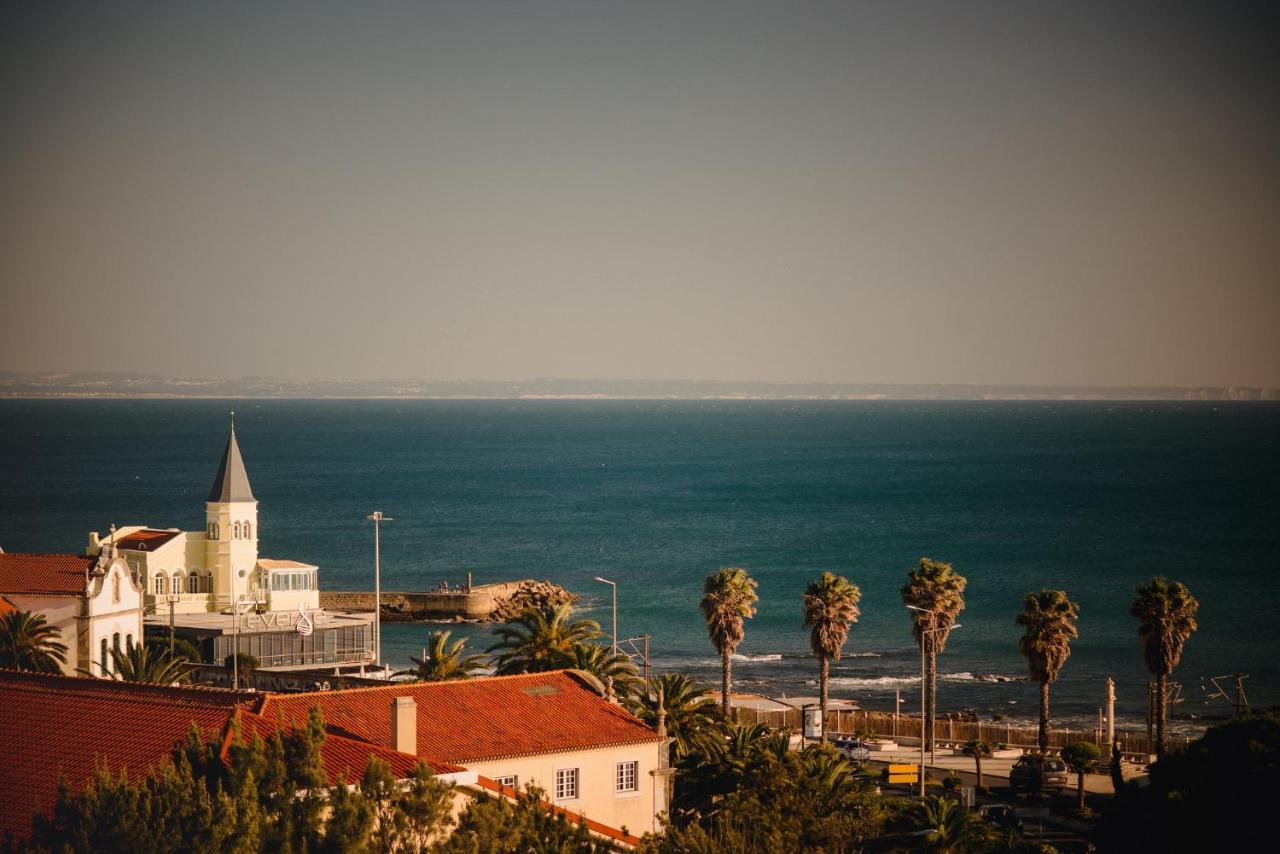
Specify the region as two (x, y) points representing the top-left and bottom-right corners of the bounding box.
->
(0, 671), (250, 839)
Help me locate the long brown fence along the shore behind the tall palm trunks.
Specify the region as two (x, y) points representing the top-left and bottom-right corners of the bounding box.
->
(733, 708), (1190, 754)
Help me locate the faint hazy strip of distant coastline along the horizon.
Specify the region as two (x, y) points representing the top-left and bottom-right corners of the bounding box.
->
(0, 371), (1280, 401)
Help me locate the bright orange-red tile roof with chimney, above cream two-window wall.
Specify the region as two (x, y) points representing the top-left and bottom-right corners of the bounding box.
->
(259, 671), (658, 764)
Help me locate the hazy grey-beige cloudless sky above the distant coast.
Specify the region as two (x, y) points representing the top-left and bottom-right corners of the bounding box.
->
(0, 0), (1280, 385)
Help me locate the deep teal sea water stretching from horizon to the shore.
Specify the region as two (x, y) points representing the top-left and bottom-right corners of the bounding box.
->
(0, 399), (1280, 723)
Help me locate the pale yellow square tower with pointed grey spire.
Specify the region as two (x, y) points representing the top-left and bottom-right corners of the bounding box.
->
(205, 416), (257, 608)
